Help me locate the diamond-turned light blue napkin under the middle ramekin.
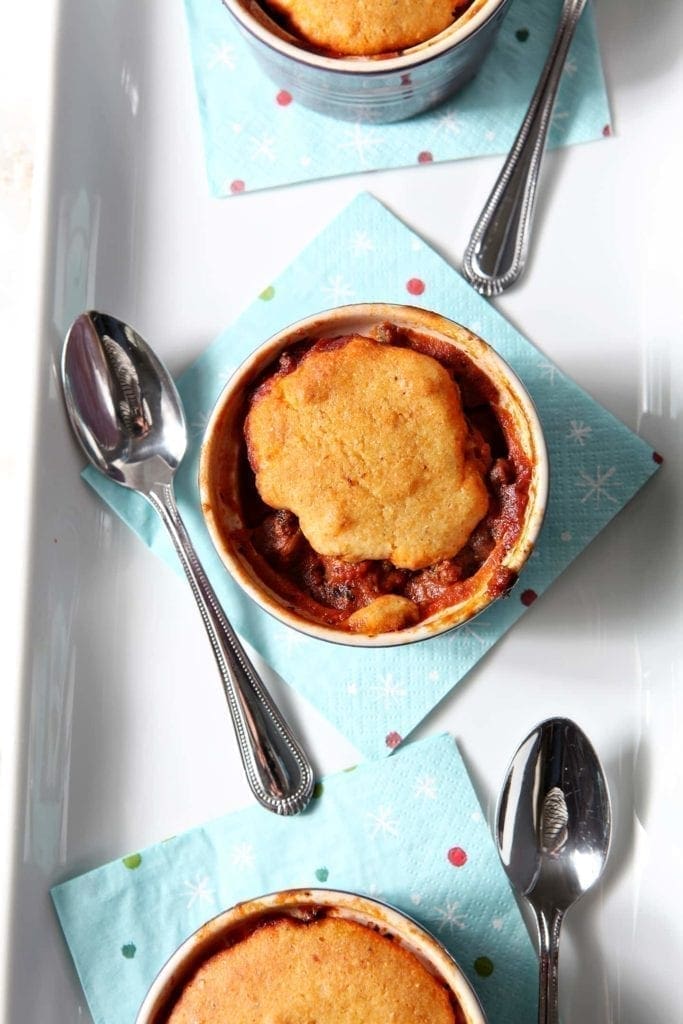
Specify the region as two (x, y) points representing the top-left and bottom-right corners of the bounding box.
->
(85, 194), (658, 757)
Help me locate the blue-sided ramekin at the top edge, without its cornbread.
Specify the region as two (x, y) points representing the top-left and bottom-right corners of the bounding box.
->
(223, 0), (516, 123)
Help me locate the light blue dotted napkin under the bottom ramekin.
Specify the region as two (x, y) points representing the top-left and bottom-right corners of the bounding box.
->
(52, 735), (537, 1024)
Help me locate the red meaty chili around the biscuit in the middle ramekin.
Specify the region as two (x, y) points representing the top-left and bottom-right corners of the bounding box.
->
(231, 324), (532, 628)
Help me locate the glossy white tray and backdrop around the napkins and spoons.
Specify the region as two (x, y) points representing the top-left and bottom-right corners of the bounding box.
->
(0, 0), (683, 1024)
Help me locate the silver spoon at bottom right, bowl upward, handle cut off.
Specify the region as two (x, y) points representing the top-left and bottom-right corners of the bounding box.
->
(497, 718), (611, 1024)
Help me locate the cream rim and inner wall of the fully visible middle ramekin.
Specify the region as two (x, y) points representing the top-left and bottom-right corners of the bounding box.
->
(199, 302), (549, 647)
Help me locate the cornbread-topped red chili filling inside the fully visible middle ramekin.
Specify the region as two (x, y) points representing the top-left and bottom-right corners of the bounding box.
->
(224, 324), (532, 636)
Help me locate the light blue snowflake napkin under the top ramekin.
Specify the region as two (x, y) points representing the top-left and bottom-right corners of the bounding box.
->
(185, 0), (610, 196)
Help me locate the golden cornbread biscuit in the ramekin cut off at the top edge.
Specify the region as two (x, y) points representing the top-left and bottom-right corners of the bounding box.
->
(266, 0), (471, 56)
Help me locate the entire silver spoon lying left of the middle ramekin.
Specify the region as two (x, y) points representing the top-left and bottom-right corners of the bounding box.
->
(61, 311), (313, 814)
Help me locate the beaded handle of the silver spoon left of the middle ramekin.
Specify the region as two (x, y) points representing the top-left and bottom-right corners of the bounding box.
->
(145, 483), (313, 814)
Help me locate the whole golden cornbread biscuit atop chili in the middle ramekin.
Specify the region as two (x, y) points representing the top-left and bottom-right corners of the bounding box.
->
(245, 335), (488, 569)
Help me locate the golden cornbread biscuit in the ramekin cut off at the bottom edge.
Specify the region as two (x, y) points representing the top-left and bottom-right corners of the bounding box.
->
(168, 918), (461, 1024)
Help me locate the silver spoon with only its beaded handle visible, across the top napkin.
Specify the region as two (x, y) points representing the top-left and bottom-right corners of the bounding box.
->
(463, 0), (586, 296)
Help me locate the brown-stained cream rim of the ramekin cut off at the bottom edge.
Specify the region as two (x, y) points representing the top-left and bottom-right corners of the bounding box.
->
(135, 889), (486, 1024)
